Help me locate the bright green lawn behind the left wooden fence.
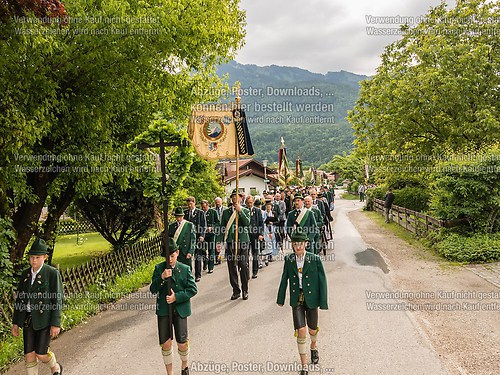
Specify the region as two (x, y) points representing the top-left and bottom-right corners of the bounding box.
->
(52, 233), (111, 269)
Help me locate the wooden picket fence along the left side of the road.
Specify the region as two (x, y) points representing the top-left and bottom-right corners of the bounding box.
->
(0, 236), (161, 334)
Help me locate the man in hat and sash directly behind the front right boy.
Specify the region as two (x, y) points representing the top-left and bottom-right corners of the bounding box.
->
(285, 193), (320, 252)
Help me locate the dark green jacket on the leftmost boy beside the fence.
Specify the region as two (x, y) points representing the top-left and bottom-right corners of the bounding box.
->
(12, 264), (64, 330)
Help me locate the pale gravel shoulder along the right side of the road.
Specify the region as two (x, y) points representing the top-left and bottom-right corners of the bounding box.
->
(348, 210), (500, 374)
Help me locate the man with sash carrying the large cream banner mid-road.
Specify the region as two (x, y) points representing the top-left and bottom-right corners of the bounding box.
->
(219, 189), (250, 300)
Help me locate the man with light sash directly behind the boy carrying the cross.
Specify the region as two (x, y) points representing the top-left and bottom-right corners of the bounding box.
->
(168, 207), (196, 268)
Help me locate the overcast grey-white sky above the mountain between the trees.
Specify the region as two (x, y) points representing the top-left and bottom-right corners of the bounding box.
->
(236, 0), (455, 75)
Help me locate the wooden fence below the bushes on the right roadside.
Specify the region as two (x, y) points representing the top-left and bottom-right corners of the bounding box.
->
(373, 199), (464, 237)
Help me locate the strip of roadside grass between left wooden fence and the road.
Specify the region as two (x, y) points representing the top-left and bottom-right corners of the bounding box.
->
(0, 257), (164, 373)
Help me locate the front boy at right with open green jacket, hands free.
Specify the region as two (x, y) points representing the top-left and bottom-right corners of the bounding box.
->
(276, 228), (328, 375)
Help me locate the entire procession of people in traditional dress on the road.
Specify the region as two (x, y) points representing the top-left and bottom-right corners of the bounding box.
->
(12, 186), (334, 375)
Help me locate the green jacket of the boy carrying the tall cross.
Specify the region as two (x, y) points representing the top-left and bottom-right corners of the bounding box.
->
(149, 261), (198, 318)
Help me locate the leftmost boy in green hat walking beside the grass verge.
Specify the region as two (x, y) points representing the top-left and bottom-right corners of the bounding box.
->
(12, 238), (64, 375)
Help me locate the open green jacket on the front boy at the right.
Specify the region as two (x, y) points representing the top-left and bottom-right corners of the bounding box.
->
(276, 252), (328, 310)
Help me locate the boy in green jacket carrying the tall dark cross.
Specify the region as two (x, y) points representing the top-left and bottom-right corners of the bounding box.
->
(149, 238), (198, 375)
